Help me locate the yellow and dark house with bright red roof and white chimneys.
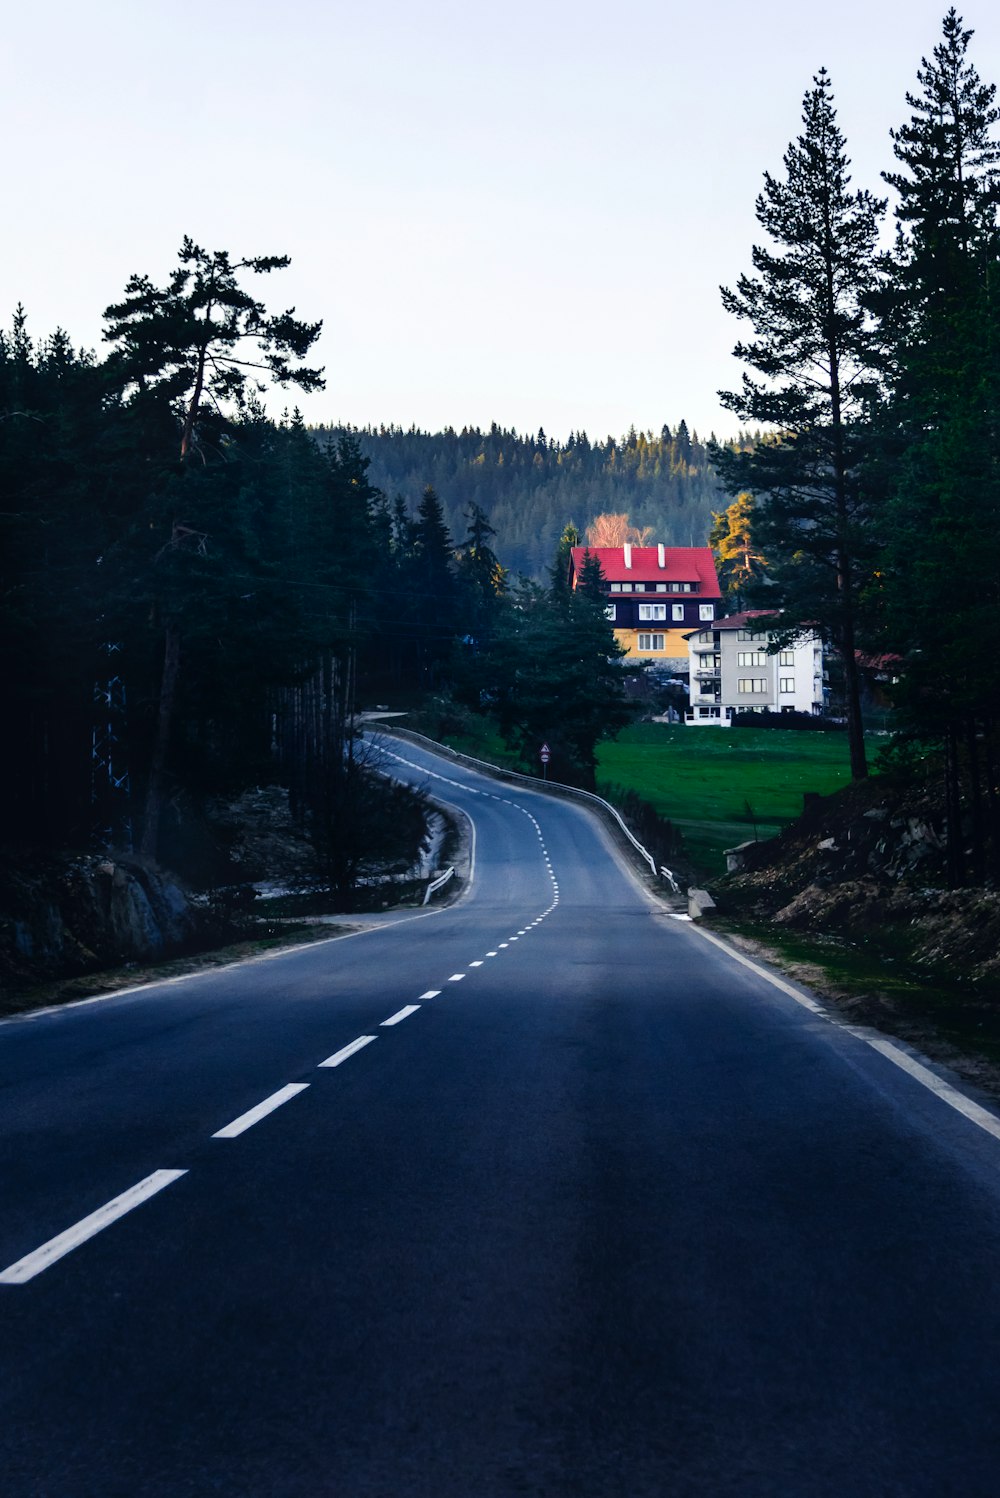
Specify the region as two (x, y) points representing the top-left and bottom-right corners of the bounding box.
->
(570, 545), (722, 656)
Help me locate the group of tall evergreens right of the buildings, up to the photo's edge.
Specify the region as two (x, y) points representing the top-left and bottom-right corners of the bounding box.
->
(711, 7), (1000, 884)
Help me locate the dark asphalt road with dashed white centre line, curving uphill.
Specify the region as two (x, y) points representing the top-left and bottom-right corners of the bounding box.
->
(0, 745), (1000, 1498)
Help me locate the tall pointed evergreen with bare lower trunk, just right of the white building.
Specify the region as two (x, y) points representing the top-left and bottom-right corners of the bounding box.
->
(714, 69), (885, 779)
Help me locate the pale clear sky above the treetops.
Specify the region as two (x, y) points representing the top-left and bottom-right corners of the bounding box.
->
(0, 0), (1000, 439)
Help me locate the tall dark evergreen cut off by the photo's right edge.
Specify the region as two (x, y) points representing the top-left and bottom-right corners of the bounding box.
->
(879, 7), (1000, 884)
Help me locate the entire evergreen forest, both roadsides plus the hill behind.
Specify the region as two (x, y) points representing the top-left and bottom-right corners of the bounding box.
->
(0, 9), (1000, 910)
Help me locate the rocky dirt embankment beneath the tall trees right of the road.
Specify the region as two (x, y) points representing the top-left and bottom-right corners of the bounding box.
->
(713, 777), (1000, 999)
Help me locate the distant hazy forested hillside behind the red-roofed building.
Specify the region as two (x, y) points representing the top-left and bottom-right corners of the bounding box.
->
(314, 421), (742, 581)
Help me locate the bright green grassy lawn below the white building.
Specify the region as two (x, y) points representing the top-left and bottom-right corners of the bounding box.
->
(597, 724), (850, 876)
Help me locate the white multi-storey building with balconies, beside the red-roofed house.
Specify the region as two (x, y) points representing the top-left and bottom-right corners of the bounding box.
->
(684, 611), (823, 728)
